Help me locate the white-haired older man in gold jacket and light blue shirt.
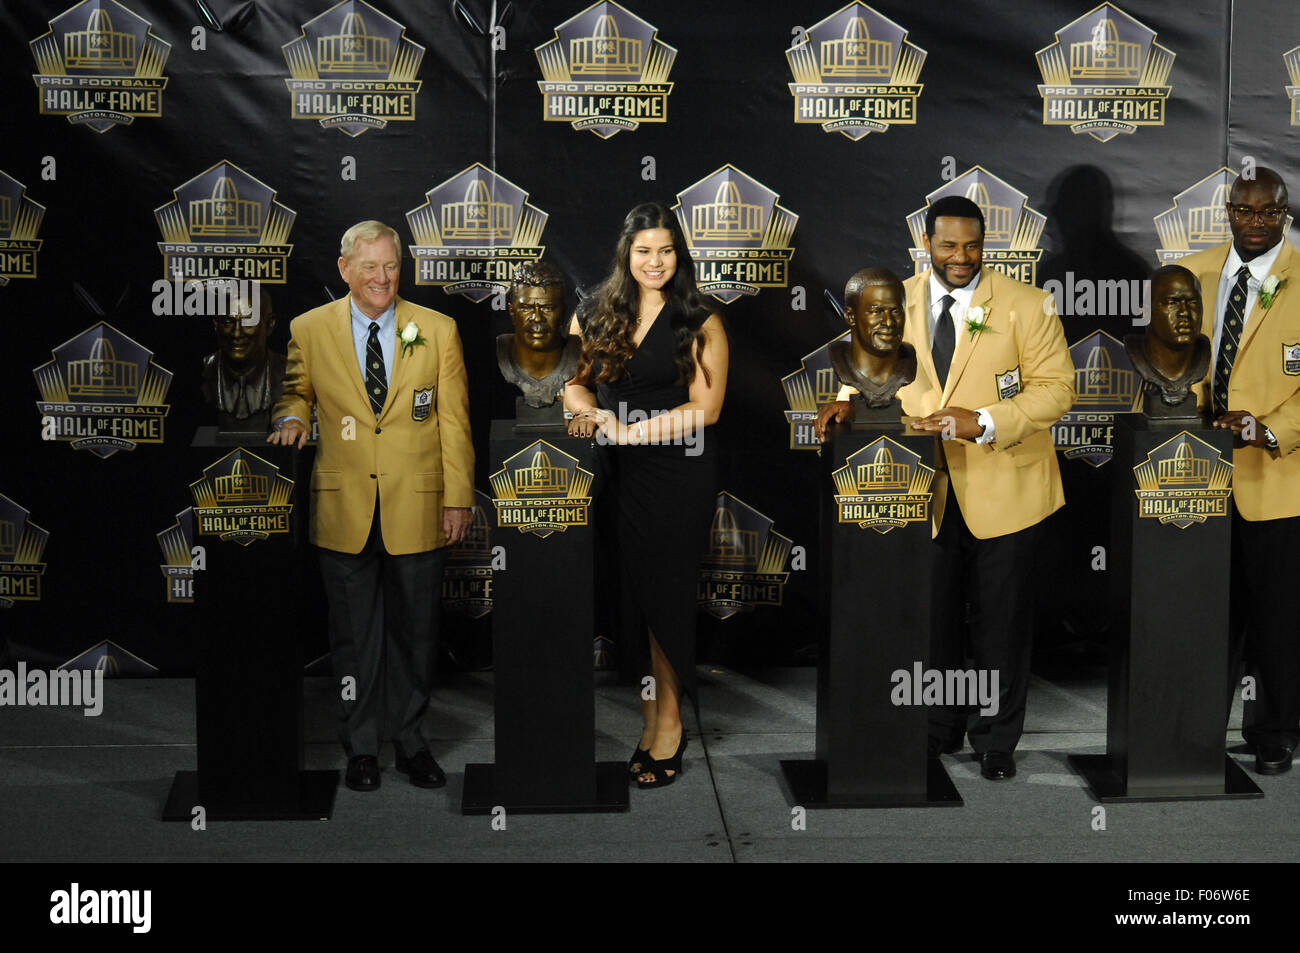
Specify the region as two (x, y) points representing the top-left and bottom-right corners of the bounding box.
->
(268, 221), (475, 790)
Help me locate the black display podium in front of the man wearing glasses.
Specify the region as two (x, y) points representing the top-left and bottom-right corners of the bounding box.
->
(1069, 413), (1264, 802)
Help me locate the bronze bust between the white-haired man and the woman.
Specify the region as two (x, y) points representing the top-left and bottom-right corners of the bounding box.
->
(497, 260), (579, 425)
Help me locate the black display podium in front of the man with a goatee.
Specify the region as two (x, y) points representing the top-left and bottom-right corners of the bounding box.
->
(781, 424), (962, 807)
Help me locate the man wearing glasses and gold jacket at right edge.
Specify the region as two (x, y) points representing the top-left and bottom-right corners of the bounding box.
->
(1179, 169), (1300, 775)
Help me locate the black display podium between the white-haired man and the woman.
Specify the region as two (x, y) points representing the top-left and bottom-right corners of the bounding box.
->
(460, 420), (628, 814)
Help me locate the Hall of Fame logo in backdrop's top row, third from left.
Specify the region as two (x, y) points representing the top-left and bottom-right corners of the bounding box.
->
(536, 1), (677, 139)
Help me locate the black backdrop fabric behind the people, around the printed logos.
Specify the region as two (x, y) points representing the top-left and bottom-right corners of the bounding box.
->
(0, 0), (1300, 673)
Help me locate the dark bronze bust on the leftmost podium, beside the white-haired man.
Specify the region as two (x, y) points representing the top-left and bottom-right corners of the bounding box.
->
(200, 282), (286, 433)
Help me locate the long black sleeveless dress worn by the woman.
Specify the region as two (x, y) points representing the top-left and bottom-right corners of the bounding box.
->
(593, 306), (716, 696)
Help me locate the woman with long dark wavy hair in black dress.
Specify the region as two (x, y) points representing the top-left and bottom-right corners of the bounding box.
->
(564, 203), (728, 788)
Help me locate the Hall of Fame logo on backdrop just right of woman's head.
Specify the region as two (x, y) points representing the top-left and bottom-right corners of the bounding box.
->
(672, 164), (800, 304)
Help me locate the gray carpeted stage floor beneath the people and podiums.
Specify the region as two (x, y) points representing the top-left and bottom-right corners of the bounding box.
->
(0, 666), (1300, 863)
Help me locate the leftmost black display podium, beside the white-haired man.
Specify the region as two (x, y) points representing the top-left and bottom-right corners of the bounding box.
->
(163, 428), (338, 820)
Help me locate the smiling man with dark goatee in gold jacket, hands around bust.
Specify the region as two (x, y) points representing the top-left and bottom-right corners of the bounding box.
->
(819, 196), (1074, 780)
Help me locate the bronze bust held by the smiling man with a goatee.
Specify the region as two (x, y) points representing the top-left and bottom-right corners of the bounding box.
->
(829, 268), (917, 423)
